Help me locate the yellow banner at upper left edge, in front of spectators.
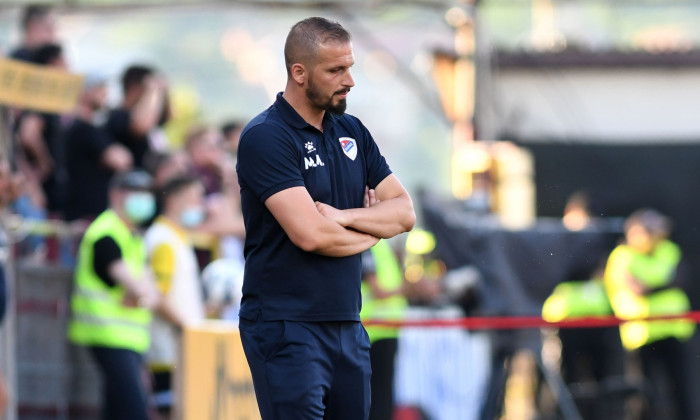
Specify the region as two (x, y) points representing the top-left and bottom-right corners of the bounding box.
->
(0, 58), (83, 113)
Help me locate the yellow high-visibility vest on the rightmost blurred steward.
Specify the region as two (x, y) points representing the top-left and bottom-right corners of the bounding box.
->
(605, 240), (695, 350)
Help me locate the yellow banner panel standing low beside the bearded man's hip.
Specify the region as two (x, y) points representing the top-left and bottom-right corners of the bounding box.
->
(178, 321), (260, 420)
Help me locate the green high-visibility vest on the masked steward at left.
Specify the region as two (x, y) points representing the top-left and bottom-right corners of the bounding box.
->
(68, 210), (151, 353)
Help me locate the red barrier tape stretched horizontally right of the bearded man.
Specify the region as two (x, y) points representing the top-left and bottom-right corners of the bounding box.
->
(362, 311), (700, 330)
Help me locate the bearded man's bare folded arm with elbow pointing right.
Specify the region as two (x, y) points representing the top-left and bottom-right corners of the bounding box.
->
(316, 174), (416, 238)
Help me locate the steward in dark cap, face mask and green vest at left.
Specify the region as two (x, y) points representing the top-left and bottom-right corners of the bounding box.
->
(68, 171), (160, 420)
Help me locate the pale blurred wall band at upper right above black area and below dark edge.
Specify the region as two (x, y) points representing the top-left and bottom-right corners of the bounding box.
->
(477, 67), (700, 143)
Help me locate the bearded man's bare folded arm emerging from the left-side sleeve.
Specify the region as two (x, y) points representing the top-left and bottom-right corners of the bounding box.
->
(265, 187), (379, 257)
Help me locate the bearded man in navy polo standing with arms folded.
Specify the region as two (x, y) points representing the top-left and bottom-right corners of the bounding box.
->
(238, 17), (415, 420)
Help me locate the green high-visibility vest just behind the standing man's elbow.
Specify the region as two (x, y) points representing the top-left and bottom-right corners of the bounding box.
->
(360, 240), (408, 342)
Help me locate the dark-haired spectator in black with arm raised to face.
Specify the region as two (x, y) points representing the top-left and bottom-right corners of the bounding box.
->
(107, 65), (170, 168)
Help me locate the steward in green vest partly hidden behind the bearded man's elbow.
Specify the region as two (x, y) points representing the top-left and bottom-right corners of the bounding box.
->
(360, 240), (408, 420)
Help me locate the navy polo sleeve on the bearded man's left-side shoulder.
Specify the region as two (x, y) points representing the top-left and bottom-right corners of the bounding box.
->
(237, 124), (304, 202)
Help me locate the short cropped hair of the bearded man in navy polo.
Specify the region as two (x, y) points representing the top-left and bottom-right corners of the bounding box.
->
(284, 17), (352, 76)
